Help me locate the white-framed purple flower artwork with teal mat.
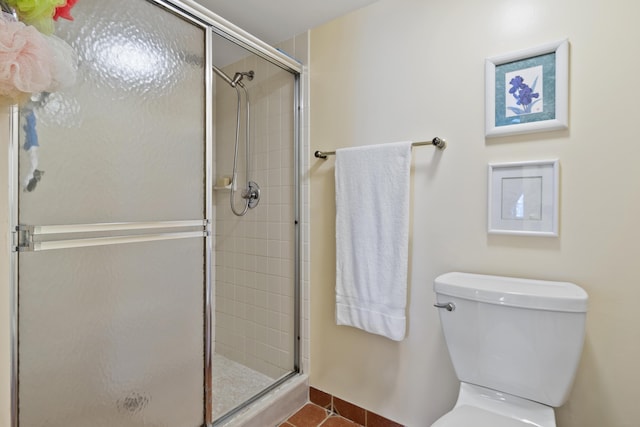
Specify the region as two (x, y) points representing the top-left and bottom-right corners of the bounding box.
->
(485, 40), (569, 137)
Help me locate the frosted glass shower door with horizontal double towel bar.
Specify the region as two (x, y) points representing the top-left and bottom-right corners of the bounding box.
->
(17, 0), (210, 427)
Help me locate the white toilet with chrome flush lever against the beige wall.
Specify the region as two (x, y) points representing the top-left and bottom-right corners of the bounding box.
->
(432, 272), (588, 427)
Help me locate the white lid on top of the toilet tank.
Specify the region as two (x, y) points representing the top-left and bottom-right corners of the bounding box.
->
(433, 272), (589, 313)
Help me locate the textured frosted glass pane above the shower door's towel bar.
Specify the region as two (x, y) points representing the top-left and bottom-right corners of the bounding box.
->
(20, 0), (205, 224)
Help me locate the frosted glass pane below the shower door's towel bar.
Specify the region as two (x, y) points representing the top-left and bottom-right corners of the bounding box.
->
(19, 238), (205, 427)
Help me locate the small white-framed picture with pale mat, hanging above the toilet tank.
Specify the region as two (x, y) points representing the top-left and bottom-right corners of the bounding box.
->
(488, 160), (559, 237)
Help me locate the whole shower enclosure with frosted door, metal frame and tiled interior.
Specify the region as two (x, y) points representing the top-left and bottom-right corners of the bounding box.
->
(10, 0), (301, 427)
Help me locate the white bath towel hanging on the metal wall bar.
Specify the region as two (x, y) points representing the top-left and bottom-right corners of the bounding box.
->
(335, 142), (411, 341)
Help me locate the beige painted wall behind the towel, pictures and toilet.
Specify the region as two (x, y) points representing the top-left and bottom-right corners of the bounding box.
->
(309, 0), (640, 427)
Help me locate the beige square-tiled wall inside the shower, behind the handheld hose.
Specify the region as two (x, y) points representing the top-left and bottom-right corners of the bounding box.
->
(214, 37), (308, 378)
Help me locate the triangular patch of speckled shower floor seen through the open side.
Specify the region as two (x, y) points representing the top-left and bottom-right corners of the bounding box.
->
(213, 353), (274, 419)
